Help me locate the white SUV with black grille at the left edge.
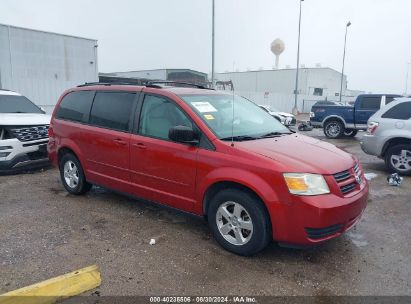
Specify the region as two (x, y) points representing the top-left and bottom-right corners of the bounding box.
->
(0, 90), (50, 173)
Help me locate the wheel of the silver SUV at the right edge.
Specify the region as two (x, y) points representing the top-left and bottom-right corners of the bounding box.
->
(385, 144), (411, 175)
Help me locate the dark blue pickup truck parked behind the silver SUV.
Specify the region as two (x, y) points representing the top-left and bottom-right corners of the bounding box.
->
(310, 94), (401, 138)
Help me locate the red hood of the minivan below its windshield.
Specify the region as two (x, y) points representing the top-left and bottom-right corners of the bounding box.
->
(235, 134), (355, 174)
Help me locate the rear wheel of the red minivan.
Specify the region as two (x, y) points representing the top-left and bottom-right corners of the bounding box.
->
(59, 153), (92, 195)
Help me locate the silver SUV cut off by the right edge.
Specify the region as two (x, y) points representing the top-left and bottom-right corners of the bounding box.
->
(361, 98), (411, 175)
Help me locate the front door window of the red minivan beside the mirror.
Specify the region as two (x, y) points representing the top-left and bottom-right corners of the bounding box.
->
(138, 95), (193, 140)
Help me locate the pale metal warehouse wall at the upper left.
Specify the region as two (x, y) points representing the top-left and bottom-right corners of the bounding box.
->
(0, 24), (98, 113)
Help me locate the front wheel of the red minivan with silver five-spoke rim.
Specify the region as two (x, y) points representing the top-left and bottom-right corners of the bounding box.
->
(207, 189), (272, 256)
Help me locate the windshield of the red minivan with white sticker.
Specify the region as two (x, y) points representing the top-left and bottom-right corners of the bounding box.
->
(181, 94), (291, 140)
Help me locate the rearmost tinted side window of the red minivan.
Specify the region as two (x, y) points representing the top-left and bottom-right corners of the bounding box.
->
(56, 91), (94, 123)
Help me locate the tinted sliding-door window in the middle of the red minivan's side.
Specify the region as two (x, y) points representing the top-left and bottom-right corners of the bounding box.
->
(90, 92), (136, 131)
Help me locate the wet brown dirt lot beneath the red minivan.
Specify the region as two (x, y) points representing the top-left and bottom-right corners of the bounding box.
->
(0, 130), (411, 296)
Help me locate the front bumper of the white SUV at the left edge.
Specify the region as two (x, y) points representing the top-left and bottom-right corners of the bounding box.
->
(0, 139), (49, 174)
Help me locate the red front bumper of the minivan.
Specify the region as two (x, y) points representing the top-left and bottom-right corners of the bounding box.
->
(272, 179), (369, 247)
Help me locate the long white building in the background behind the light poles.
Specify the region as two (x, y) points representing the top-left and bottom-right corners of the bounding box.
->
(216, 67), (361, 112)
